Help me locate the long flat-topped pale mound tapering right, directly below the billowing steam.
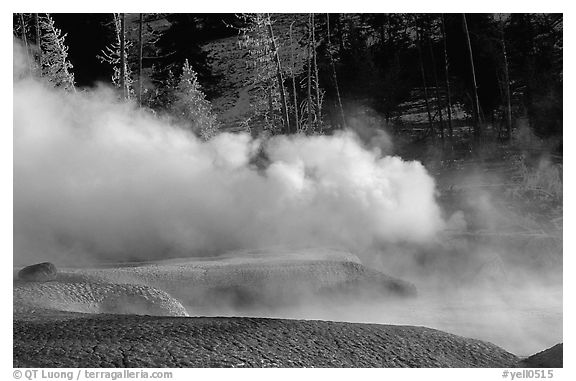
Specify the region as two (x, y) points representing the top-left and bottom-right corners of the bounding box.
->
(39, 249), (416, 311)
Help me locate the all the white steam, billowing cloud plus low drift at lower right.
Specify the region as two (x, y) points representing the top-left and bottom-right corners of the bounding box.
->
(14, 44), (562, 354)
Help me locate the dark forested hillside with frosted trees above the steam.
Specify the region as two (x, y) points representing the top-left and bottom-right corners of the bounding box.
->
(13, 13), (563, 151)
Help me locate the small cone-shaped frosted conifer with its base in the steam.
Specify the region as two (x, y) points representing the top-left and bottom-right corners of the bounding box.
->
(171, 60), (218, 140)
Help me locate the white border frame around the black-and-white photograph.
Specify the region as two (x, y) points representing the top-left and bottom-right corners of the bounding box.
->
(0, 0), (576, 381)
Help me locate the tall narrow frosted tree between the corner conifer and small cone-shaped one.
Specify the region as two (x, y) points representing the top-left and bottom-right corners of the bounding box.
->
(98, 13), (135, 99)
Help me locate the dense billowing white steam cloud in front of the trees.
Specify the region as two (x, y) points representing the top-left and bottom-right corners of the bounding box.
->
(14, 45), (443, 263)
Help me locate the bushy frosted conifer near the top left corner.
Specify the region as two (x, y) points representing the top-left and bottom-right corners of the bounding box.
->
(39, 14), (75, 91)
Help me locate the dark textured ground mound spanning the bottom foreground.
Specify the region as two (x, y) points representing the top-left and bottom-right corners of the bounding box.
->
(13, 314), (522, 367)
